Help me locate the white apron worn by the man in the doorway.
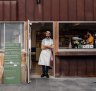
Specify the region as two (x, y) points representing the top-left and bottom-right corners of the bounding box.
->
(38, 39), (53, 66)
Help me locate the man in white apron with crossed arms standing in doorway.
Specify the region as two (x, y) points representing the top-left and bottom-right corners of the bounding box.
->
(38, 31), (53, 78)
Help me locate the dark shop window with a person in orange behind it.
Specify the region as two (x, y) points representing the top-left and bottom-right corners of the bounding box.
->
(59, 23), (96, 49)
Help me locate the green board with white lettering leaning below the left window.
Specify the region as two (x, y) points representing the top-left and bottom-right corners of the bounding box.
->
(4, 43), (21, 84)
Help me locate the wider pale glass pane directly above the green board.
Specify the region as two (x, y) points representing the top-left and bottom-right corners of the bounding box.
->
(5, 23), (24, 48)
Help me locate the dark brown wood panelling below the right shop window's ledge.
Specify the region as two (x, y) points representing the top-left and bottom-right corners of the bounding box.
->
(56, 56), (96, 77)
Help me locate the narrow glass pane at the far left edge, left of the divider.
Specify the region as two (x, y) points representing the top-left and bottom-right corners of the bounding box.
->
(0, 23), (4, 49)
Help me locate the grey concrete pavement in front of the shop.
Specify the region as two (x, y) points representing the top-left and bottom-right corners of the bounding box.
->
(0, 77), (96, 91)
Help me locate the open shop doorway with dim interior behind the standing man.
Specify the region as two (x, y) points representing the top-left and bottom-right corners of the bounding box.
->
(30, 22), (55, 78)
